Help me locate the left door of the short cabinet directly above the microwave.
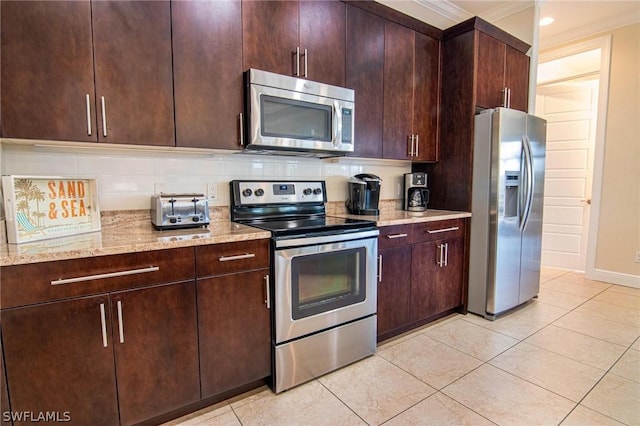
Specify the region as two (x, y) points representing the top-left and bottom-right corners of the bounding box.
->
(242, 0), (300, 75)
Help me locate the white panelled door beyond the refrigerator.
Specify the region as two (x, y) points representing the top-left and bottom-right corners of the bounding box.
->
(536, 76), (598, 271)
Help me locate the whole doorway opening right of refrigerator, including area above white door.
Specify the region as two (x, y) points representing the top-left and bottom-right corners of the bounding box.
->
(535, 37), (610, 276)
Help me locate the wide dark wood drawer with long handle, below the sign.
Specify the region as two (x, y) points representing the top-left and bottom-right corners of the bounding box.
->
(0, 247), (195, 308)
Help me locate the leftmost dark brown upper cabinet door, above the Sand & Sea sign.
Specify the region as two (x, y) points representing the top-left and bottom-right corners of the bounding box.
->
(0, 1), (97, 142)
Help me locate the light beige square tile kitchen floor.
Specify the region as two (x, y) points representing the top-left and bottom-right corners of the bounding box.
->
(170, 269), (640, 426)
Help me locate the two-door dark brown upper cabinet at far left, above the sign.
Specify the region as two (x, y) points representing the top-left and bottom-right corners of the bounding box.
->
(1, 1), (175, 146)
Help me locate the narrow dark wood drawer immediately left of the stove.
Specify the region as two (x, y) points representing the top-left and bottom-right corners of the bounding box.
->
(196, 239), (269, 277)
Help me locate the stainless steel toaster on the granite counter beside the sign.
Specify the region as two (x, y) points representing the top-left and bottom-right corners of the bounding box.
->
(151, 193), (210, 230)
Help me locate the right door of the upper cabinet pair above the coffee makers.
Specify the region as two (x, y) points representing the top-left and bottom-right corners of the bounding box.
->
(412, 33), (440, 161)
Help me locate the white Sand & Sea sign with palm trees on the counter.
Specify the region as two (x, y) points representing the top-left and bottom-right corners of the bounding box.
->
(2, 176), (100, 244)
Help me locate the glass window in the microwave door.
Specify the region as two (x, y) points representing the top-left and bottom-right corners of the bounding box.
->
(260, 95), (333, 142)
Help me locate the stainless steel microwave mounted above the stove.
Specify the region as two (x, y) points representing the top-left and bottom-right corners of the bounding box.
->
(242, 69), (355, 158)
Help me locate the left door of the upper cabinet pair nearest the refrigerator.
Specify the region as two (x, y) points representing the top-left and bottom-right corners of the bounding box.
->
(382, 21), (415, 160)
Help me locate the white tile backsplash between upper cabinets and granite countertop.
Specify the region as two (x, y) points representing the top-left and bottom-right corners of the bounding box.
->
(0, 141), (411, 211)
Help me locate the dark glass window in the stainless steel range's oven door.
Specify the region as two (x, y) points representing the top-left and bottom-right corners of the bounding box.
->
(291, 247), (366, 320)
